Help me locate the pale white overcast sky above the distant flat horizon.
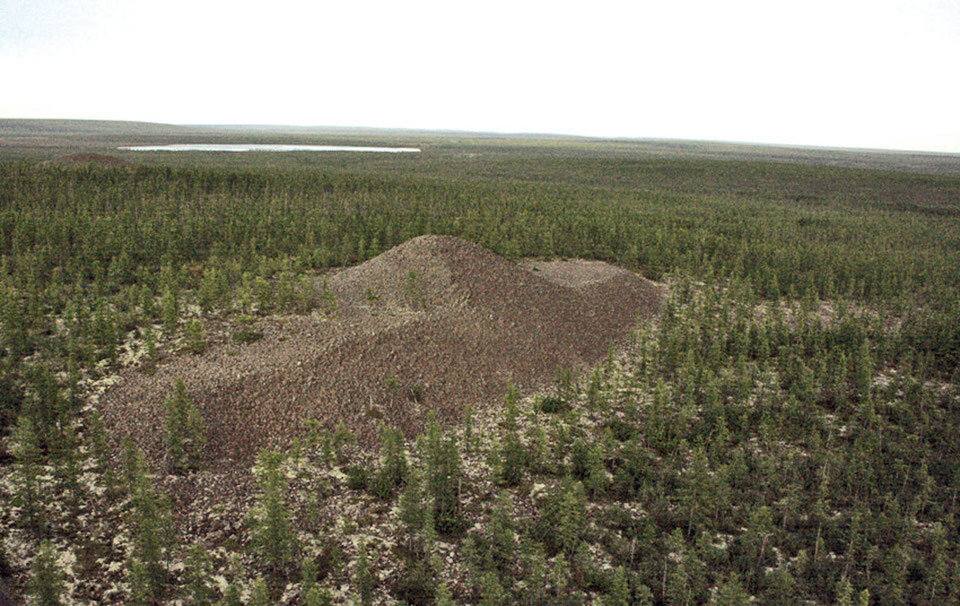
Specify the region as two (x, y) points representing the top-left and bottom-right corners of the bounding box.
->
(0, 0), (960, 153)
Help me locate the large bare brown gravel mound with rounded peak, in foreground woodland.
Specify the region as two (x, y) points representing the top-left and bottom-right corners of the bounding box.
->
(100, 236), (661, 464)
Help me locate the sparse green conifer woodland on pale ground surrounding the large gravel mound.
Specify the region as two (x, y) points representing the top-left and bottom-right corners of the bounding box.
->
(0, 152), (960, 606)
